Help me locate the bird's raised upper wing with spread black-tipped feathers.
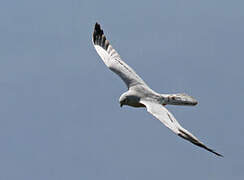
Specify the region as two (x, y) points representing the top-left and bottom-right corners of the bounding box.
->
(92, 23), (145, 89)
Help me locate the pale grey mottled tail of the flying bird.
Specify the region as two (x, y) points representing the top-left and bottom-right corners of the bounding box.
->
(161, 93), (198, 106)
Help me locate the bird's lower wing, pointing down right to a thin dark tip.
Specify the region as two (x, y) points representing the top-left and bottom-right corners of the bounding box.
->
(140, 100), (222, 156)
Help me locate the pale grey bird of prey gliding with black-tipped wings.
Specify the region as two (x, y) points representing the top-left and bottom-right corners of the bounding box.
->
(92, 23), (222, 156)
